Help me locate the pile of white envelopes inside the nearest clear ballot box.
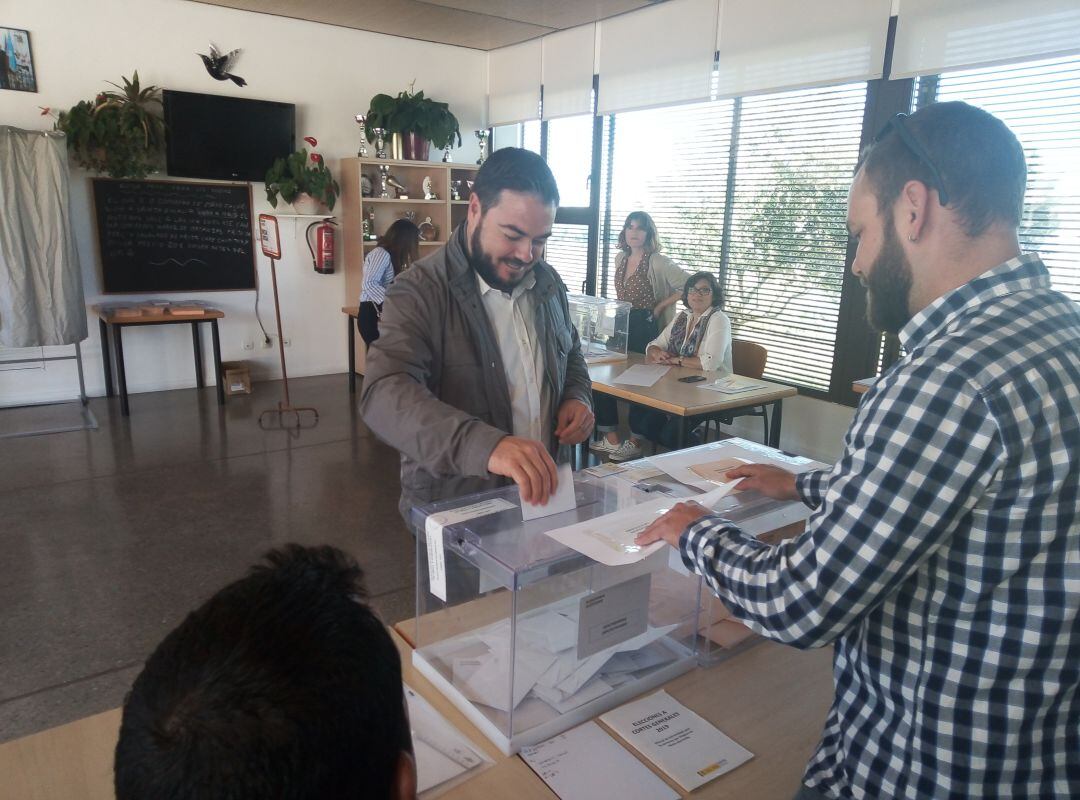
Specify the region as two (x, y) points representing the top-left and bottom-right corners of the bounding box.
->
(424, 598), (679, 714)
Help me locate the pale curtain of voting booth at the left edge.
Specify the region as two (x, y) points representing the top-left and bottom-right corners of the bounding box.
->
(0, 125), (86, 348)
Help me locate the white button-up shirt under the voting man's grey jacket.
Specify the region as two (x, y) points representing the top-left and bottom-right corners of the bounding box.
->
(476, 272), (553, 448)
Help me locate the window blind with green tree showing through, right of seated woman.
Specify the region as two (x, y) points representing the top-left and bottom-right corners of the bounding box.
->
(724, 83), (866, 392)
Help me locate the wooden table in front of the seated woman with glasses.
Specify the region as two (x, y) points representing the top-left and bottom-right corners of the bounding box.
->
(589, 353), (798, 449)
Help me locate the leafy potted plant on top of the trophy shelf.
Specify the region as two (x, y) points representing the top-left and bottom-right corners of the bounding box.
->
(366, 82), (461, 161)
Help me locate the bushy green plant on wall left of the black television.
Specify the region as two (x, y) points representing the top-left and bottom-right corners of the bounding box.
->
(51, 70), (165, 178)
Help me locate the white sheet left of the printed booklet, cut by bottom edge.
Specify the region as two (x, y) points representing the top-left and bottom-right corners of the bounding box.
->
(522, 722), (678, 800)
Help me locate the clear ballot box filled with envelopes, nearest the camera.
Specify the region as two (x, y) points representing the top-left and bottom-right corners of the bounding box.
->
(411, 475), (700, 755)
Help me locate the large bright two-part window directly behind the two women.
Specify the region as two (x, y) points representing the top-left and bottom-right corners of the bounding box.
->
(602, 83), (866, 392)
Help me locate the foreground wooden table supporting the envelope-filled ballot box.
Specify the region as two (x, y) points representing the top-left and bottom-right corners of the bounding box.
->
(0, 630), (833, 800)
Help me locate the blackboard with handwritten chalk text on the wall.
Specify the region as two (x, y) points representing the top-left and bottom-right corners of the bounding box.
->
(94, 178), (255, 294)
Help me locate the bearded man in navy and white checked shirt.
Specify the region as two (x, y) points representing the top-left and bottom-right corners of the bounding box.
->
(638, 103), (1080, 799)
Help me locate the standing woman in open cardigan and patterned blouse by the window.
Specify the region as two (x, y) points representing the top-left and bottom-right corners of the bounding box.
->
(591, 212), (687, 453)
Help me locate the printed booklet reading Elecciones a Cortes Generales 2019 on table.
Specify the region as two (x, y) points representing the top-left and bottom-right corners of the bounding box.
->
(600, 692), (754, 791)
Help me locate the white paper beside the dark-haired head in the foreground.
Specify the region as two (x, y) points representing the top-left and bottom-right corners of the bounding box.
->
(405, 686), (491, 795)
